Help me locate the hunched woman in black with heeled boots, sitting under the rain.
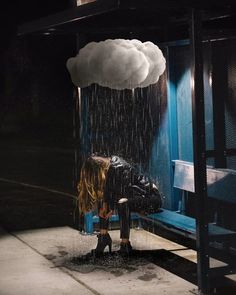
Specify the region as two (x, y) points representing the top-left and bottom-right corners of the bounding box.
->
(78, 155), (162, 255)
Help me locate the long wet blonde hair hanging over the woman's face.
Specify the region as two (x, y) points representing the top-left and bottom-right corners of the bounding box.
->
(77, 157), (110, 214)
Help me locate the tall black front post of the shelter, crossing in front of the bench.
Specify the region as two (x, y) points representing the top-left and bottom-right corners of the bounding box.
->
(190, 9), (209, 294)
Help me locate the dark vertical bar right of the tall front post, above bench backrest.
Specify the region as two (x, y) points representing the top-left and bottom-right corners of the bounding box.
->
(212, 41), (228, 168)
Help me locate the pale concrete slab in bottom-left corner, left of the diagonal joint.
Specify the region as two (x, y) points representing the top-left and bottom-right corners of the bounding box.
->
(0, 230), (94, 295)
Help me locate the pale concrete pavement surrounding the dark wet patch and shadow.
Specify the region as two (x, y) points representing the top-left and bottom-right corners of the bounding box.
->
(0, 227), (197, 295)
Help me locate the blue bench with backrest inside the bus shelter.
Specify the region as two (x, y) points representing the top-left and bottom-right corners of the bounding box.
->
(85, 160), (236, 240)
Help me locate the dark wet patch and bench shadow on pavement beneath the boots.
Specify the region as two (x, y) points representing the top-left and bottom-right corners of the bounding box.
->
(64, 249), (197, 284)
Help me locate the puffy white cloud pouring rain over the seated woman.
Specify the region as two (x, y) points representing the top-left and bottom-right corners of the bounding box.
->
(66, 39), (166, 90)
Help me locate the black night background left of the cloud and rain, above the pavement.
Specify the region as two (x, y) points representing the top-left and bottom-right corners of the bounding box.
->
(0, 0), (76, 230)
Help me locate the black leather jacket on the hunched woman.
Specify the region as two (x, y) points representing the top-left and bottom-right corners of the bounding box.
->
(104, 156), (162, 213)
